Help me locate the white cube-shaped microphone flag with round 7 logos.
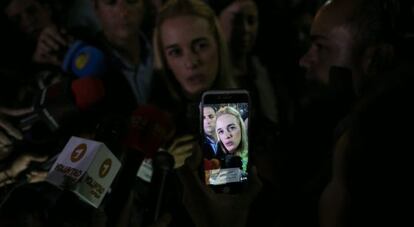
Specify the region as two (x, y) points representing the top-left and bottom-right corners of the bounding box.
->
(46, 136), (121, 208)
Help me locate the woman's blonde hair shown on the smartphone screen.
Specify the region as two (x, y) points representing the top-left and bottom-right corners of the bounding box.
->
(216, 106), (248, 170)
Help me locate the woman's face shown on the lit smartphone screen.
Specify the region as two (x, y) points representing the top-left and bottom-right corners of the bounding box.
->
(216, 114), (241, 153)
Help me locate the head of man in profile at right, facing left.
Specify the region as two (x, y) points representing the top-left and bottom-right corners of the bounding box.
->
(300, 0), (394, 95)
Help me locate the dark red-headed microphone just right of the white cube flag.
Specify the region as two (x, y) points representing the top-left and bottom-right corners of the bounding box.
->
(106, 105), (173, 226)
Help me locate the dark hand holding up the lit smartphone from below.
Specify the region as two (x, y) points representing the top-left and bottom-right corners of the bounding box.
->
(178, 143), (262, 226)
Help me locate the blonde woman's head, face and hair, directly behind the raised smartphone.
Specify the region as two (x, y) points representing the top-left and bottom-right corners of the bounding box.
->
(153, 0), (235, 101)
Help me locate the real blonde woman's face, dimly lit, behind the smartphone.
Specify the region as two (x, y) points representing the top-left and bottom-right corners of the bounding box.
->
(160, 16), (219, 96)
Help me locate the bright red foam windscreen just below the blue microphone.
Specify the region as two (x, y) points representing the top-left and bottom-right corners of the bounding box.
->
(72, 77), (105, 110)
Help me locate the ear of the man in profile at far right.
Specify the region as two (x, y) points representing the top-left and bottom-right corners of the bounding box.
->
(362, 43), (395, 75)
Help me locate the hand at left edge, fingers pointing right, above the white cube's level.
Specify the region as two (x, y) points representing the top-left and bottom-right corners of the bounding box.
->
(0, 107), (33, 160)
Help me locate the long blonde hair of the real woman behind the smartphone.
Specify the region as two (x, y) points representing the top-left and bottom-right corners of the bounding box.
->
(153, 0), (236, 98)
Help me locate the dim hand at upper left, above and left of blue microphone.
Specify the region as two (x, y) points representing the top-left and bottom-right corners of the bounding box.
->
(32, 25), (69, 66)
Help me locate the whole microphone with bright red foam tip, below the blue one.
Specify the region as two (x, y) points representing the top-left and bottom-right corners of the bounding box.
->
(20, 77), (105, 132)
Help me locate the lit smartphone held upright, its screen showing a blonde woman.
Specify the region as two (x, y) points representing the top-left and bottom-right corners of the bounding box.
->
(200, 90), (251, 193)
